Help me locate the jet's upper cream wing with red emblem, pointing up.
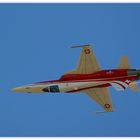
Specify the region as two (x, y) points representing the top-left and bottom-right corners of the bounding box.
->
(73, 45), (100, 74)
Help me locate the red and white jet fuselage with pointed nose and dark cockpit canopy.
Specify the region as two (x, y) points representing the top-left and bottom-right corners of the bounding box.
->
(12, 69), (140, 93)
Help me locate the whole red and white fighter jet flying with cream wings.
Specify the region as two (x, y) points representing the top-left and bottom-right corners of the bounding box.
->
(12, 45), (140, 112)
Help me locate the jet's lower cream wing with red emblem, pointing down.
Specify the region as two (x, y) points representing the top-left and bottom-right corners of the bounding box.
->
(83, 88), (113, 112)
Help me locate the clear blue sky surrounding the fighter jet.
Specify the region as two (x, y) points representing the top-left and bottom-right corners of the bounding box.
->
(0, 4), (140, 136)
